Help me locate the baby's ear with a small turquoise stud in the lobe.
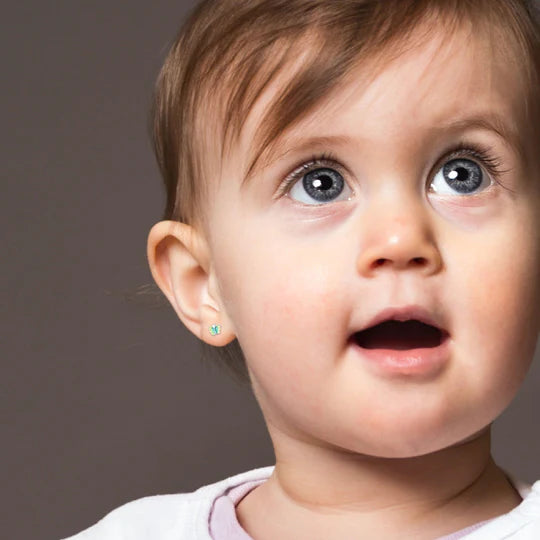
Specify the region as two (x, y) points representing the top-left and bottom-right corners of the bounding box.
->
(146, 221), (235, 347)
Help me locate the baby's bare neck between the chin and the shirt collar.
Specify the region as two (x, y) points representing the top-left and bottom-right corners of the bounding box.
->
(238, 427), (521, 538)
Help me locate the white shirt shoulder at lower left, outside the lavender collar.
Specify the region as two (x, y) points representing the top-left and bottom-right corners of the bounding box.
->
(60, 466), (274, 540)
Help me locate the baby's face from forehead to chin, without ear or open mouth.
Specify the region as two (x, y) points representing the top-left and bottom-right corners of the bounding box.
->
(205, 24), (540, 457)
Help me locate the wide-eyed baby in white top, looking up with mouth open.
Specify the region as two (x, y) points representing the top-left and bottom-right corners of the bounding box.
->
(64, 0), (540, 540)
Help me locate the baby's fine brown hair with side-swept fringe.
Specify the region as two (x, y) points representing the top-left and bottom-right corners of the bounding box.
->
(144, 0), (540, 383)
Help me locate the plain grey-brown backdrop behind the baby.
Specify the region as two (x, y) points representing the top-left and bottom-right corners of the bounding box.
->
(4, 0), (540, 539)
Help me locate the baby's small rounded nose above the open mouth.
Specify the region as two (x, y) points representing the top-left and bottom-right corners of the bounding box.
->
(358, 207), (442, 277)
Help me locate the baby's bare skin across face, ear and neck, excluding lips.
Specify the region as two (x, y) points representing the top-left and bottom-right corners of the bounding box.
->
(148, 20), (540, 540)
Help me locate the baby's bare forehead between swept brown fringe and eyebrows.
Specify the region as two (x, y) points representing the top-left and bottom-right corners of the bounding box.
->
(227, 21), (525, 187)
